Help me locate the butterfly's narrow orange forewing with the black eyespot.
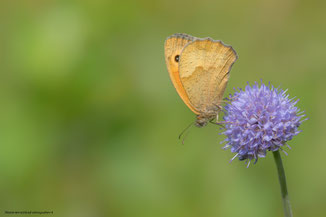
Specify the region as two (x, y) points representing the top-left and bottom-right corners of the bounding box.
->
(164, 33), (198, 114)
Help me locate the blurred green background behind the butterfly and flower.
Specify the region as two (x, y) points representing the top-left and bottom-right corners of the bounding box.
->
(0, 0), (326, 217)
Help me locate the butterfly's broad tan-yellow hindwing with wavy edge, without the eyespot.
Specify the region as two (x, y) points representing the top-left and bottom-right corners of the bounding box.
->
(179, 38), (237, 114)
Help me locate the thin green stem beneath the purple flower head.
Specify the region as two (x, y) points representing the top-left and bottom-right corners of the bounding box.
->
(273, 151), (293, 217)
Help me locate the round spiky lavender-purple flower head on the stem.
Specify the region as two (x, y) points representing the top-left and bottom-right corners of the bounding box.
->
(222, 83), (305, 166)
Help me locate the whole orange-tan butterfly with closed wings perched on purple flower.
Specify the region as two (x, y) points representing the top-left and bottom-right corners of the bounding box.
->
(164, 33), (238, 127)
